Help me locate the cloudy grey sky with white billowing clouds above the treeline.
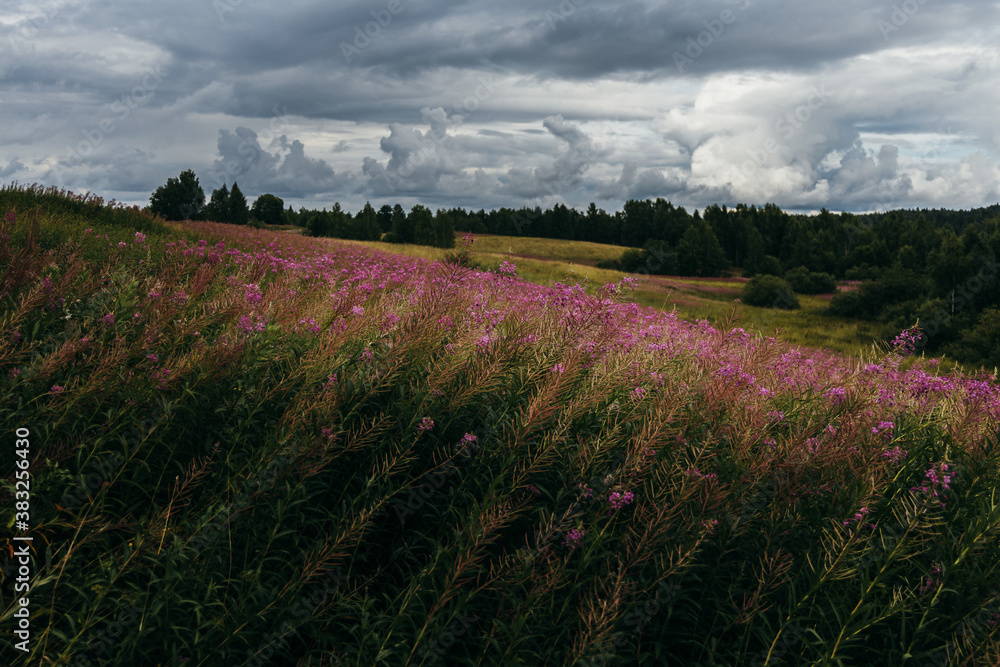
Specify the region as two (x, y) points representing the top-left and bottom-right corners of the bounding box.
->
(0, 0), (1000, 212)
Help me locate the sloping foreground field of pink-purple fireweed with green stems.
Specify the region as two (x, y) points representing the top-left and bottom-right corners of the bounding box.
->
(0, 186), (1000, 666)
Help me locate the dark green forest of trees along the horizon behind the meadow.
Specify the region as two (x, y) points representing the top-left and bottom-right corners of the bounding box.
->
(151, 172), (1000, 369)
